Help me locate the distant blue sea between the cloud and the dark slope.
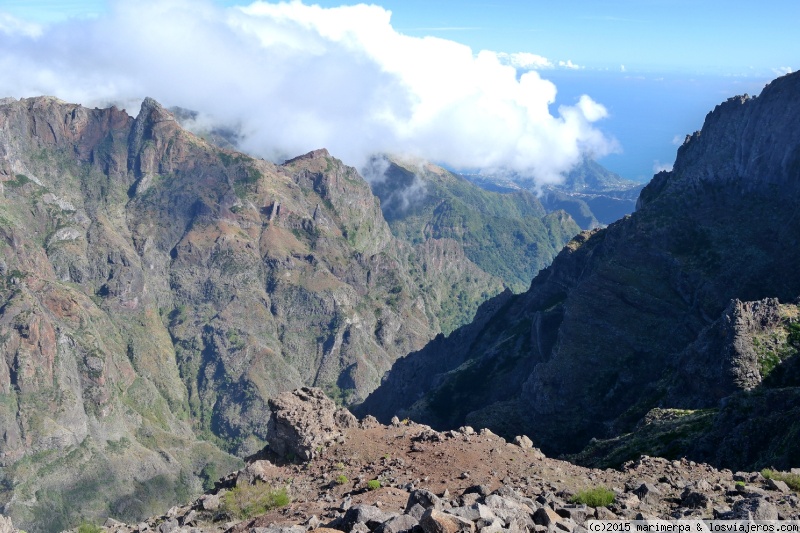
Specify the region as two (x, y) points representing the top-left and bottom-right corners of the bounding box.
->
(540, 70), (777, 182)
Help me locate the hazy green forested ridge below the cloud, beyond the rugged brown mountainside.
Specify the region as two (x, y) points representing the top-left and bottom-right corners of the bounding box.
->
(370, 157), (580, 294)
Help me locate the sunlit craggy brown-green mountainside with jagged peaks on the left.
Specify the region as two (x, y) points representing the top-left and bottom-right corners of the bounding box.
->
(0, 97), (488, 531)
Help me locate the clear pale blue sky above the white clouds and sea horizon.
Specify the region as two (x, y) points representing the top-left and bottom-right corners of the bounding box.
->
(6, 0), (800, 76)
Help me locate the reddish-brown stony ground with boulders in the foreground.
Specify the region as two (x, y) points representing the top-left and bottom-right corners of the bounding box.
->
(20, 388), (800, 533)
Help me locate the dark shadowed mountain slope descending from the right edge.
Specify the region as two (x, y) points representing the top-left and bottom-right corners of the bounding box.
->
(363, 74), (800, 466)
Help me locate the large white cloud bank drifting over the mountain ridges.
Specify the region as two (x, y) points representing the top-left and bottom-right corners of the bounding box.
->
(0, 0), (614, 184)
